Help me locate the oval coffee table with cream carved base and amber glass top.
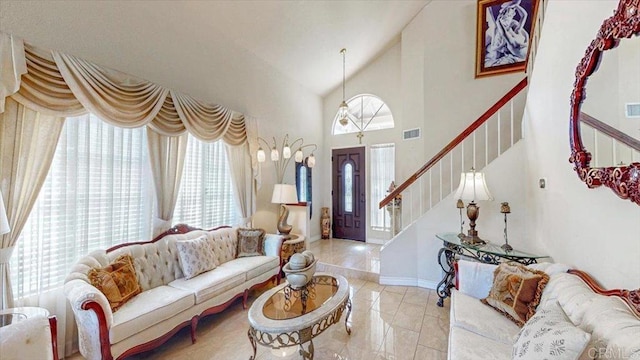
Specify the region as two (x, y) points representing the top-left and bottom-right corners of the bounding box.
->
(247, 273), (351, 360)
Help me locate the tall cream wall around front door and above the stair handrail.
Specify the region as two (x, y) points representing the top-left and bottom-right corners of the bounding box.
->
(323, 0), (525, 243)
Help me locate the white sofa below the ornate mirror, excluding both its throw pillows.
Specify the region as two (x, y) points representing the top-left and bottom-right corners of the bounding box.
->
(448, 260), (640, 360)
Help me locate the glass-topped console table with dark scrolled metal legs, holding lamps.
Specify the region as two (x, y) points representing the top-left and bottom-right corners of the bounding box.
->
(436, 233), (548, 307)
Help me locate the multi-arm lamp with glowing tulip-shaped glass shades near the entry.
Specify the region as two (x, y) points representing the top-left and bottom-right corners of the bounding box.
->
(256, 134), (318, 184)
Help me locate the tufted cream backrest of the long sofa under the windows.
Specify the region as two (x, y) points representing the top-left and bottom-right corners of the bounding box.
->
(65, 228), (238, 291)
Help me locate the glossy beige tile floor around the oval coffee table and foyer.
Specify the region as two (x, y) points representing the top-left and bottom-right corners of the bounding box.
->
(70, 239), (449, 360)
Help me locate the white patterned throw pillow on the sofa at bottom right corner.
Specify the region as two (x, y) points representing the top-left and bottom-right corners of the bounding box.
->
(512, 302), (591, 360)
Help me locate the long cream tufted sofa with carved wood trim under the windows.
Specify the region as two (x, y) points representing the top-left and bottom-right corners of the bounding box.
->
(64, 225), (282, 359)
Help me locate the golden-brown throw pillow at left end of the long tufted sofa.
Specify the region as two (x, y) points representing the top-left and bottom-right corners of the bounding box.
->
(87, 255), (142, 312)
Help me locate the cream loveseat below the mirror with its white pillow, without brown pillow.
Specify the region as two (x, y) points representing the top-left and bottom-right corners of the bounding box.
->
(448, 260), (640, 360)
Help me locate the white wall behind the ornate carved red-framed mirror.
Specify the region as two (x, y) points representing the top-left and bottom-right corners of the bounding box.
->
(525, 0), (640, 289)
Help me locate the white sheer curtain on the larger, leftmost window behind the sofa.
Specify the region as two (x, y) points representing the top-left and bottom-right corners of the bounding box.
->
(11, 115), (153, 355)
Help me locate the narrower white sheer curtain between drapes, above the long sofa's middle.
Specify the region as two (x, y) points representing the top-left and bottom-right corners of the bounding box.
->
(173, 135), (242, 229)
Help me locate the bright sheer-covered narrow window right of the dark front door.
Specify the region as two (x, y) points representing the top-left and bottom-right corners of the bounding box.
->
(370, 144), (395, 231)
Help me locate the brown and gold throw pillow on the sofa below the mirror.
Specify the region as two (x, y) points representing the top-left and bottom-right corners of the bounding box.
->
(481, 262), (549, 326)
